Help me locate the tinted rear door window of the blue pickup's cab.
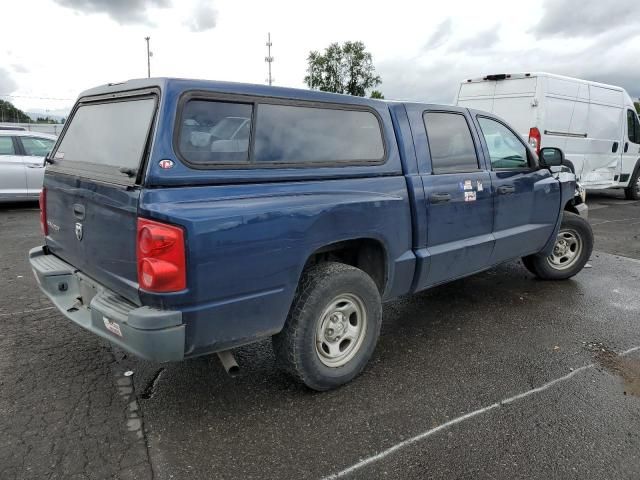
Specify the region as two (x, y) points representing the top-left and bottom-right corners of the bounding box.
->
(422, 112), (479, 174)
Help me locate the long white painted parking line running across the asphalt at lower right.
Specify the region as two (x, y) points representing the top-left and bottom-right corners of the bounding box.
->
(322, 346), (640, 480)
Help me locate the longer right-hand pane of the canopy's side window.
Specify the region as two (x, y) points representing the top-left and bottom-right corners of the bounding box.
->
(254, 104), (384, 164)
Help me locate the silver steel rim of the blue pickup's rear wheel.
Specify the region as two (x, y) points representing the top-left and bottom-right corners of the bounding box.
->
(316, 293), (367, 368)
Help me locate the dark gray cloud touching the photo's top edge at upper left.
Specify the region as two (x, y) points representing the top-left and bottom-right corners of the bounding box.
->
(54, 0), (171, 24)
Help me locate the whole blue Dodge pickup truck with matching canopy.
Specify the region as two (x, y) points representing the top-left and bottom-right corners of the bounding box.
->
(29, 79), (593, 390)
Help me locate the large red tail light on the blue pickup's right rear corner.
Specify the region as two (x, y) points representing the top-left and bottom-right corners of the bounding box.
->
(137, 218), (187, 293)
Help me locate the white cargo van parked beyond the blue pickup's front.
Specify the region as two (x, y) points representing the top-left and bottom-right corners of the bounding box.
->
(454, 73), (640, 200)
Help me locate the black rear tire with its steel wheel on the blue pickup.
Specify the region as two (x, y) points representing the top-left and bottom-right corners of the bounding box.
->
(272, 262), (382, 391)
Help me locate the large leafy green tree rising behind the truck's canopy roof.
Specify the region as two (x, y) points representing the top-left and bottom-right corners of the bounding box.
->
(304, 42), (382, 97)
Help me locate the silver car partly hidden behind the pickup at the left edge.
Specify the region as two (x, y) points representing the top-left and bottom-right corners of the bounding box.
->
(0, 130), (57, 202)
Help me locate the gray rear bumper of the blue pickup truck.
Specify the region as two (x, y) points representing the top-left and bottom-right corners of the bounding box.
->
(29, 247), (185, 362)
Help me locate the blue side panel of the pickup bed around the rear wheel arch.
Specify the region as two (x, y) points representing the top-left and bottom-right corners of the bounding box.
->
(140, 175), (415, 356)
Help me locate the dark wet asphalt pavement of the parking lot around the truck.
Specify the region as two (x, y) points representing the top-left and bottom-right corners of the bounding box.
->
(0, 192), (640, 479)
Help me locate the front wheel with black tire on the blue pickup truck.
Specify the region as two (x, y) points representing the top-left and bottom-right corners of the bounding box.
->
(522, 211), (593, 280)
